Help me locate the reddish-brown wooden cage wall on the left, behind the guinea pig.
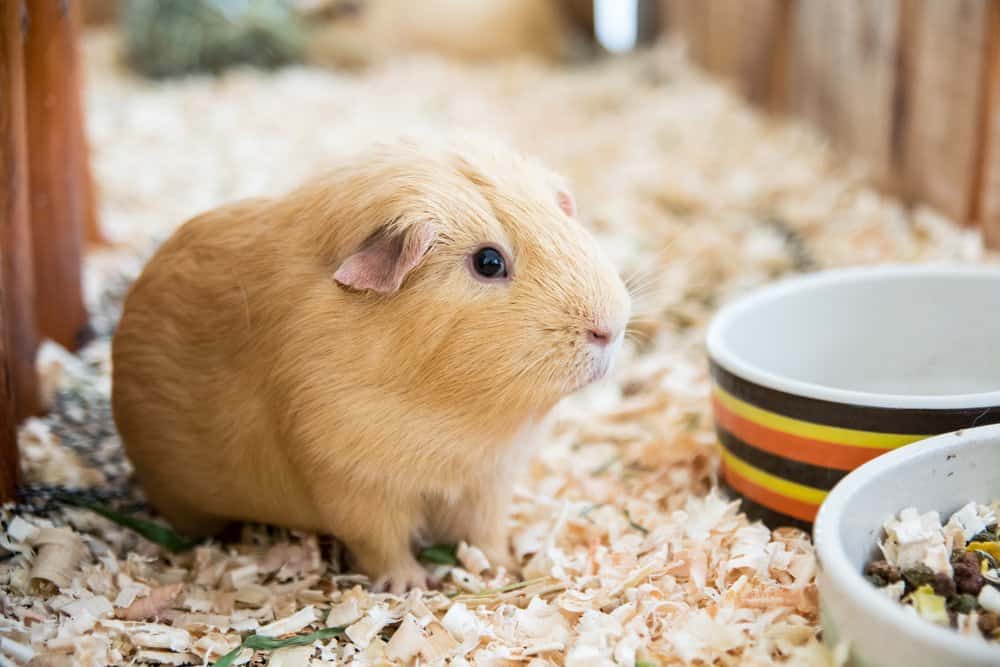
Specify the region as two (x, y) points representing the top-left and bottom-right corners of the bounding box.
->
(0, 0), (101, 502)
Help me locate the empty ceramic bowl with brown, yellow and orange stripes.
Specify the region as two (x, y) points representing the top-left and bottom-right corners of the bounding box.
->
(708, 266), (1000, 529)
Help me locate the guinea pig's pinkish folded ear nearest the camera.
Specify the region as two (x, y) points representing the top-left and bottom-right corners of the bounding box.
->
(333, 223), (437, 294)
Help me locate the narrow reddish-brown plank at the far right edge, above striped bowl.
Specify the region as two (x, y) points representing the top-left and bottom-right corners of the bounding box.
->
(973, 2), (1000, 249)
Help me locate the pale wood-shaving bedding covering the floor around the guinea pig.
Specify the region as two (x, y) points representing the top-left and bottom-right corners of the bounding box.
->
(0, 30), (988, 666)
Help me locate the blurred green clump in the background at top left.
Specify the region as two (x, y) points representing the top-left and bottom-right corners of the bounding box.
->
(120, 0), (305, 78)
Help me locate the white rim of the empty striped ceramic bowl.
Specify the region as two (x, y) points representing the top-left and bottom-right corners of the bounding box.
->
(706, 263), (1000, 410)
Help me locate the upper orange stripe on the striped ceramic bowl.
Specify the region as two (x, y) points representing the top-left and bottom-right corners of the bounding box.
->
(712, 396), (885, 470)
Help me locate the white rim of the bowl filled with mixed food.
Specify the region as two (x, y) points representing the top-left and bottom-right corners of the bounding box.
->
(812, 424), (1000, 664)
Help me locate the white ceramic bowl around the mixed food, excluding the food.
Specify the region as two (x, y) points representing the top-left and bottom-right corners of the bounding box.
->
(813, 424), (1000, 667)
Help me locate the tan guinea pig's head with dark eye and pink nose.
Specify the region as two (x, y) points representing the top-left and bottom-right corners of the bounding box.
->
(318, 145), (630, 424)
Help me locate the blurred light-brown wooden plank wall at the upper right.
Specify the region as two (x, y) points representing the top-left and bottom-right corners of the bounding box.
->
(661, 0), (1000, 247)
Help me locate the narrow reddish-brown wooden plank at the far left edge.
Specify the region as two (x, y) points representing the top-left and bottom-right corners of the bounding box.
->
(0, 0), (38, 419)
